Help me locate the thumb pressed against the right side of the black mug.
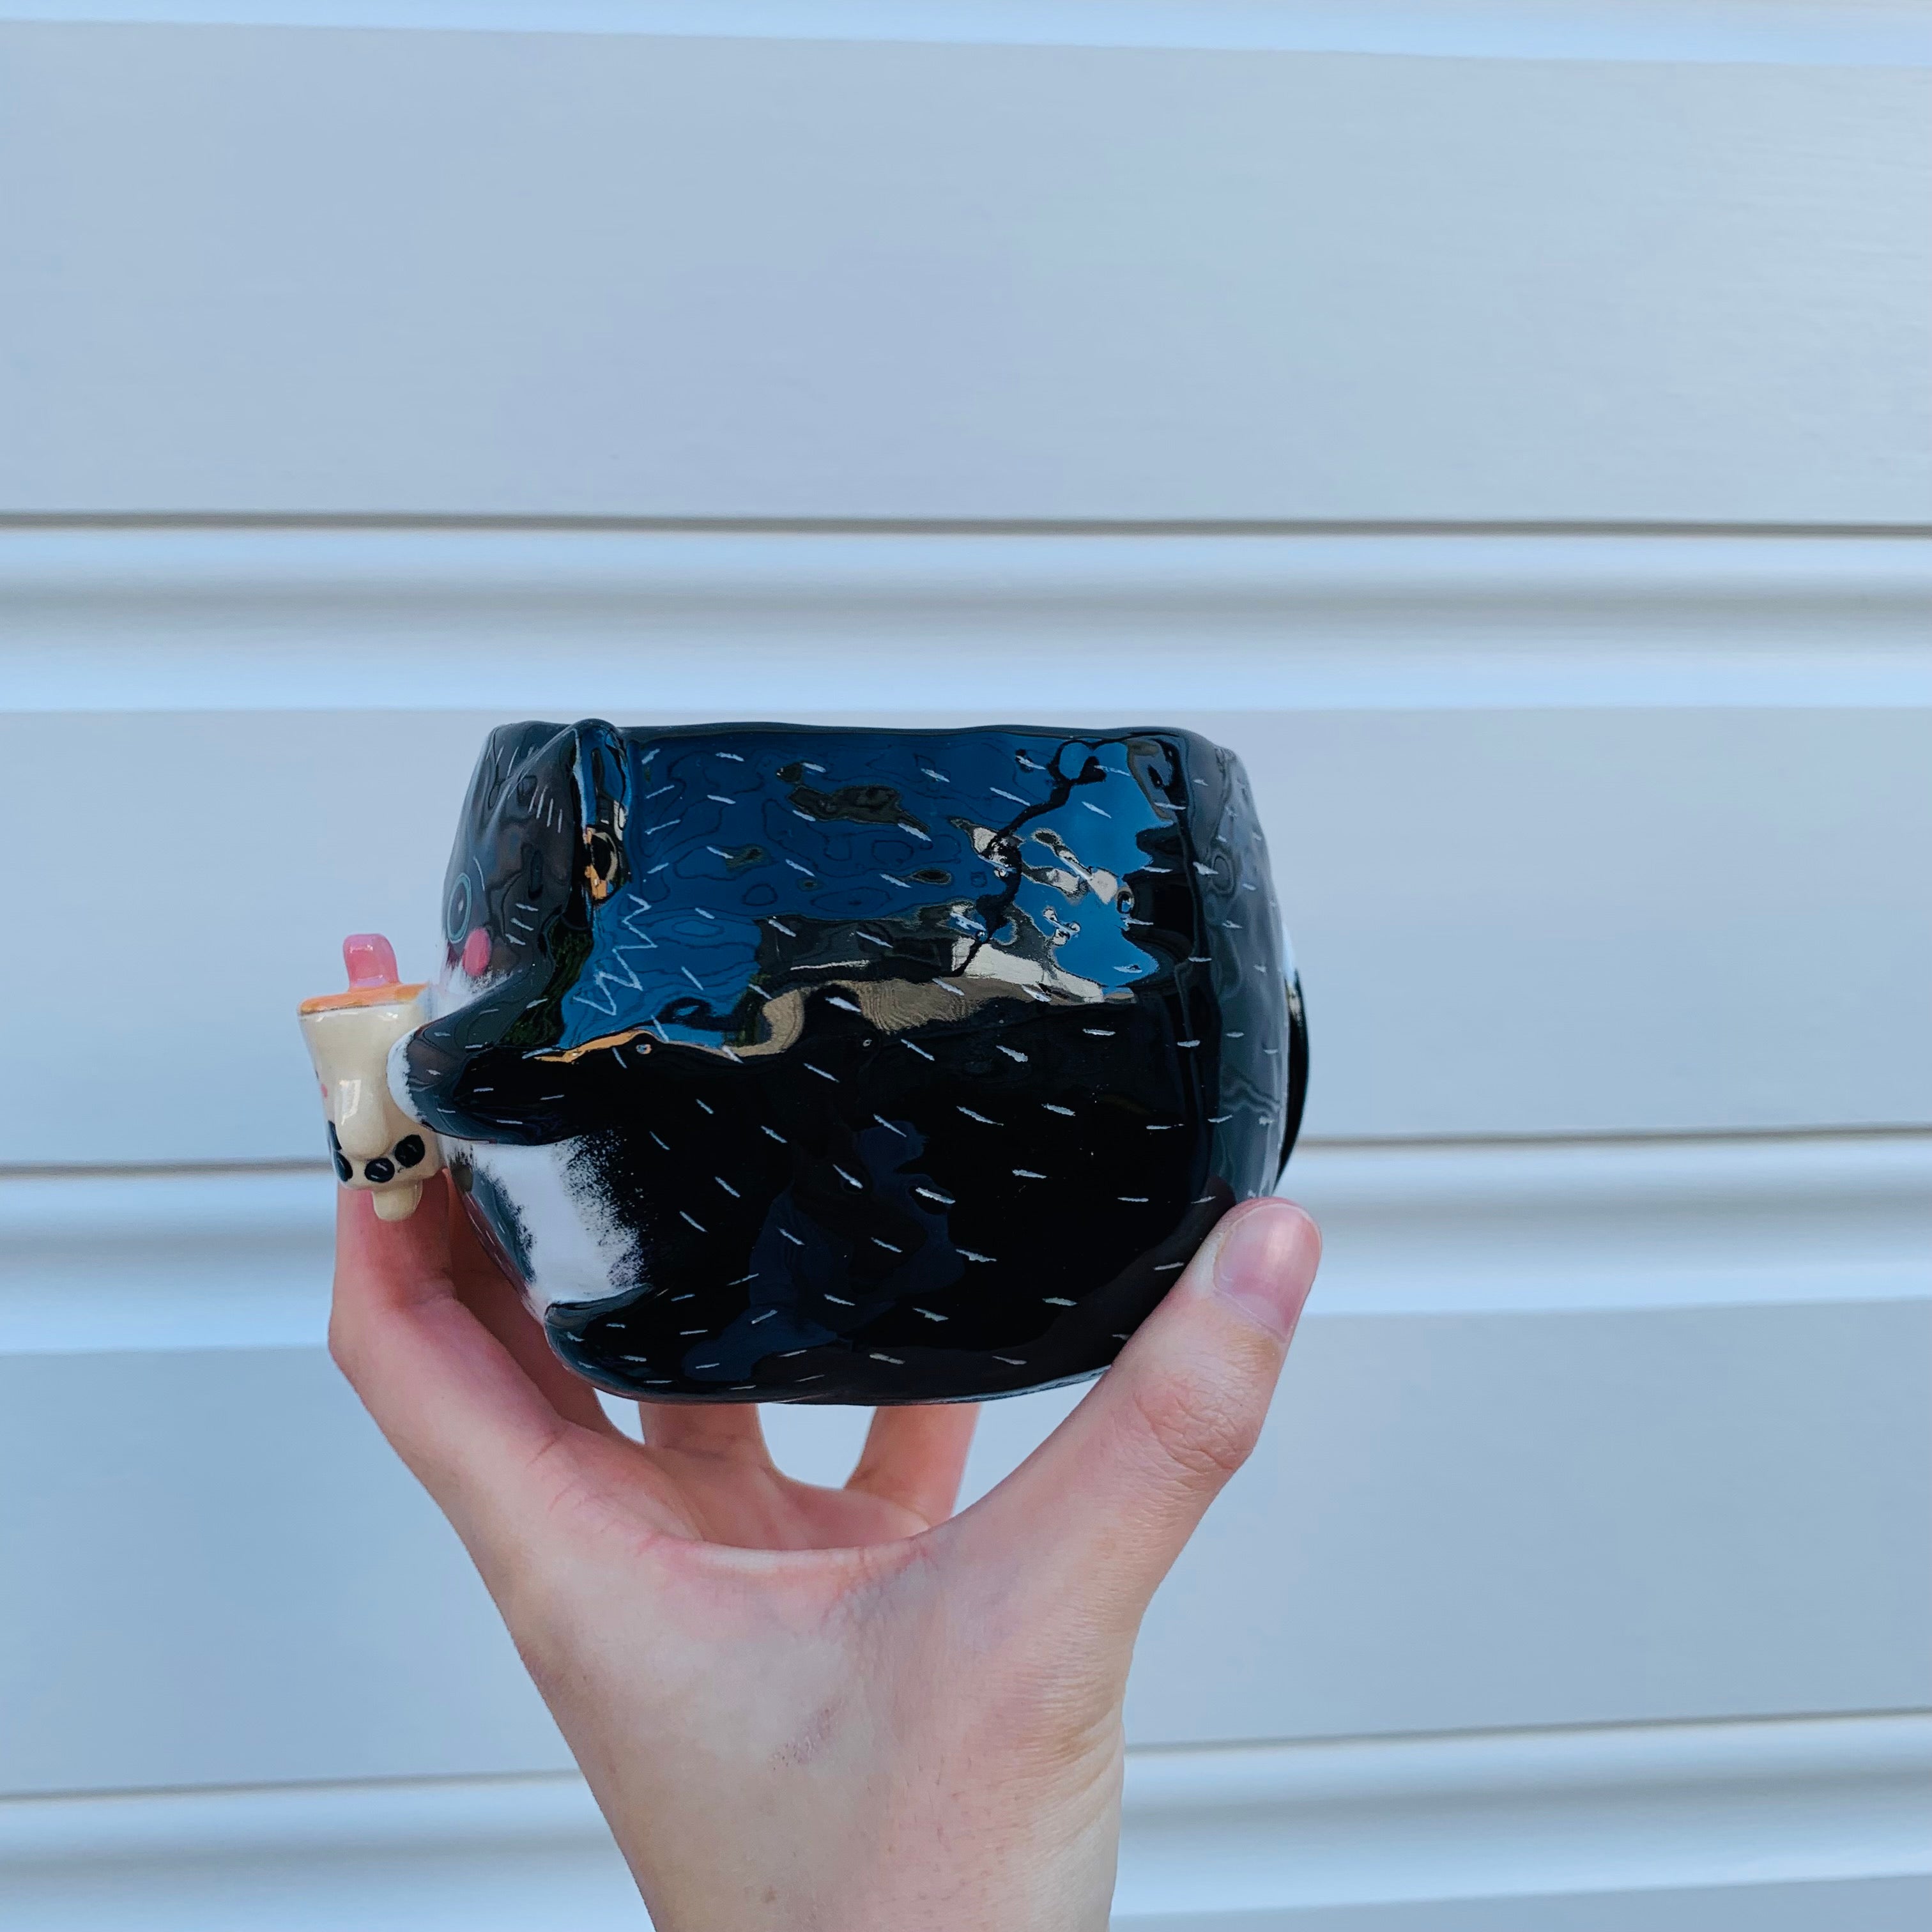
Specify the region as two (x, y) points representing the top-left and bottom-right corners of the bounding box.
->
(956, 1198), (1321, 1632)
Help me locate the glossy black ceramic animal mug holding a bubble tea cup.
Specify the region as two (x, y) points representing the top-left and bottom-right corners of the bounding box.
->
(303, 721), (1308, 1404)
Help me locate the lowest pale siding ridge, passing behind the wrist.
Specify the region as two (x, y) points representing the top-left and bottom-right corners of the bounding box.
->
(0, 1712), (1932, 1919)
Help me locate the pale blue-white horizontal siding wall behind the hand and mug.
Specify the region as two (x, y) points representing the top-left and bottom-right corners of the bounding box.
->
(0, 0), (1932, 1932)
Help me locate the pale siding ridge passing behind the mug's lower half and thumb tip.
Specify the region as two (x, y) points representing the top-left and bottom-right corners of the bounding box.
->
(0, 1132), (1932, 1356)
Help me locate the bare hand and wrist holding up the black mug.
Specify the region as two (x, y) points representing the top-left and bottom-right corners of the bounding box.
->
(328, 1175), (1321, 1932)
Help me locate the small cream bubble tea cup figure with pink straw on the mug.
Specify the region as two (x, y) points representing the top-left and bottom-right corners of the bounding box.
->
(298, 933), (442, 1221)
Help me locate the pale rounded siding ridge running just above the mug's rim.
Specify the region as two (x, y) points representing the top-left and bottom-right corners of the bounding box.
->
(0, 518), (1932, 723)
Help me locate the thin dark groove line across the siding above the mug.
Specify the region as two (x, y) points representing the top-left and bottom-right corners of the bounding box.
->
(11, 510), (1932, 543)
